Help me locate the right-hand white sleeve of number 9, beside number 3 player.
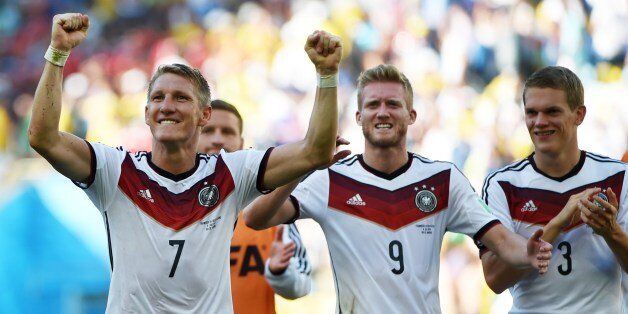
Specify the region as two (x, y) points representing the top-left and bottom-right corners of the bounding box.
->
(447, 167), (499, 240)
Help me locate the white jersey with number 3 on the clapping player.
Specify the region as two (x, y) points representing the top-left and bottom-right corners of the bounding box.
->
(482, 152), (628, 313)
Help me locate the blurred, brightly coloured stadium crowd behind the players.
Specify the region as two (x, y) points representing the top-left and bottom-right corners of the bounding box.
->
(0, 0), (628, 312)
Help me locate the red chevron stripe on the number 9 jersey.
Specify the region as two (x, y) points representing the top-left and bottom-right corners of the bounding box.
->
(328, 169), (450, 230)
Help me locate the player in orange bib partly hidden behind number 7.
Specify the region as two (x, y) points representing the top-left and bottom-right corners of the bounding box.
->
(199, 99), (311, 314)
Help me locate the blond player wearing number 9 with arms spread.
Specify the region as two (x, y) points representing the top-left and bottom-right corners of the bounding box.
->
(239, 65), (551, 313)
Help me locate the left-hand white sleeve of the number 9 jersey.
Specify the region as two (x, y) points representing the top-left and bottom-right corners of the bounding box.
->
(290, 169), (329, 222)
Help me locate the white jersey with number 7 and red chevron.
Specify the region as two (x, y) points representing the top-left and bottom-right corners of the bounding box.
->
(77, 144), (270, 313)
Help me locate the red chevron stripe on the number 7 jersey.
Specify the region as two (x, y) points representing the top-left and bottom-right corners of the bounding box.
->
(118, 155), (235, 231)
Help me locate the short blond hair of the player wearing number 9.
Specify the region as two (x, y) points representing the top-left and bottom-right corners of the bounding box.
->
(358, 64), (413, 110)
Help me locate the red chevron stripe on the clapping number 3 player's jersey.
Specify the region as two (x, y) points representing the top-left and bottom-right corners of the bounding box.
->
(498, 171), (625, 230)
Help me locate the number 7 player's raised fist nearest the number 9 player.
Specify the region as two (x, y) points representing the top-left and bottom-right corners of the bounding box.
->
(305, 31), (342, 75)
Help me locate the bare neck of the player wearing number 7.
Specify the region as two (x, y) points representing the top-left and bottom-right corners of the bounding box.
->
(151, 142), (196, 174)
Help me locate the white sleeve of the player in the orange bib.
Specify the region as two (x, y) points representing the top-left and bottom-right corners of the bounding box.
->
(264, 224), (312, 299)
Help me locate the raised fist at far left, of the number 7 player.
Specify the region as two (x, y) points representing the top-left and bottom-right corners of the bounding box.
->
(50, 13), (89, 52)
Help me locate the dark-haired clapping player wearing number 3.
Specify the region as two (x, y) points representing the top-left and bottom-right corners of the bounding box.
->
(481, 66), (628, 313)
